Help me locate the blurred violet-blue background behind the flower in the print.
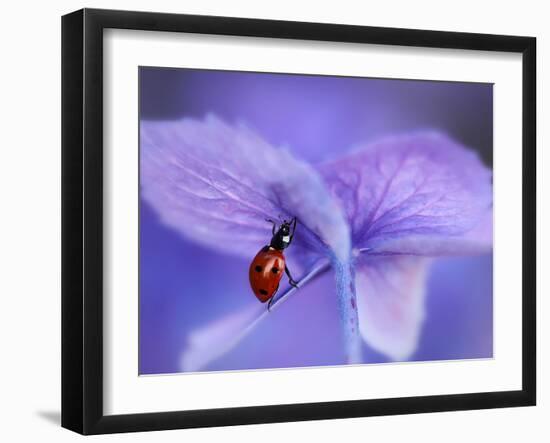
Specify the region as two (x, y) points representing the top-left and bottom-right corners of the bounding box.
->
(139, 68), (493, 374)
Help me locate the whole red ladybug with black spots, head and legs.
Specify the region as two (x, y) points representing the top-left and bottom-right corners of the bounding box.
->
(248, 217), (298, 311)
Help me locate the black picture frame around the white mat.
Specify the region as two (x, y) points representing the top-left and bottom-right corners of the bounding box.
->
(62, 9), (536, 434)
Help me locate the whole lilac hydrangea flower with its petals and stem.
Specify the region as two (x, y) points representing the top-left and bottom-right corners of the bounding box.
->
(140, 116), (492, 371)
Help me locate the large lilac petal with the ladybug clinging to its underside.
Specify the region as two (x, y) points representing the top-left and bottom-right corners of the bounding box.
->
(140, 116), (350, 257)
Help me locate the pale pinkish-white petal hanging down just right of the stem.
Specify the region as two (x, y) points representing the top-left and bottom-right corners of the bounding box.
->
(355, 256), (432, 360)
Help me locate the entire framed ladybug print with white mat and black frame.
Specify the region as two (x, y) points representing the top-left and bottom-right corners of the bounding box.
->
(62, 9), (536, 434)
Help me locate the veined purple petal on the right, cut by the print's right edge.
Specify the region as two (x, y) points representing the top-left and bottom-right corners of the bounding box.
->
(319, 132), (492, 255)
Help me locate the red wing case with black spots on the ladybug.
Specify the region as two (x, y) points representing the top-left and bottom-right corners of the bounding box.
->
(248, 246), (285, 303)
